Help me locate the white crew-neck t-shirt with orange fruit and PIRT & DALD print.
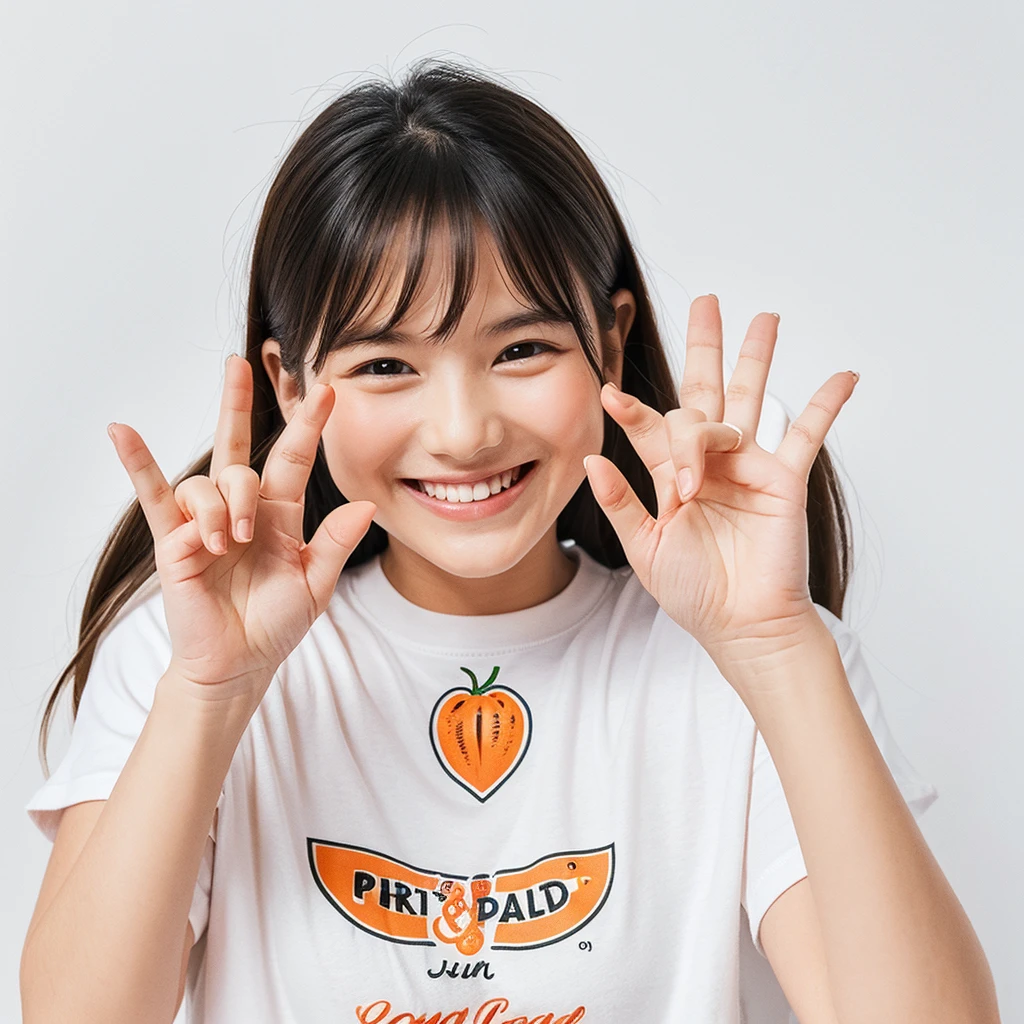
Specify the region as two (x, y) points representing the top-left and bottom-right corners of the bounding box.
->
(26, 546), (937, 1024)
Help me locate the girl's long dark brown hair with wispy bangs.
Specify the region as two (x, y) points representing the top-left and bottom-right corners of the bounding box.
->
(32, 59), (851, 771)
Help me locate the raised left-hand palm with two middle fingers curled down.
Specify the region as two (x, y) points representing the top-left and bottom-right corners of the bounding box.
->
(109, 356), (377, 700)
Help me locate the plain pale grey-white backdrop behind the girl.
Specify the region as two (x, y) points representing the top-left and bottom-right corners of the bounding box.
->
(0, 0), (1024, 1022)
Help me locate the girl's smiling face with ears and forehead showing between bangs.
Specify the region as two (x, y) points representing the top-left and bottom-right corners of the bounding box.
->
(264, 219), (635, 606)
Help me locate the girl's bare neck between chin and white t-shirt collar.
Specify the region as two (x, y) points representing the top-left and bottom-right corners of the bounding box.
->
(381, 527), (577, 615)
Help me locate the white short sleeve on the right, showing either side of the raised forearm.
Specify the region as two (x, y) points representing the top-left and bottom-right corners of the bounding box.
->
(742, 604), (938, 956)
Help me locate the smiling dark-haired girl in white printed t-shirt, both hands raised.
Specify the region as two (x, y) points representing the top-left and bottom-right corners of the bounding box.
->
(22, 62), (997, 1024)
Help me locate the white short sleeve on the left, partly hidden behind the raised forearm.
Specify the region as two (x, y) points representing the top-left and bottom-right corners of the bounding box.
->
(25, 586), (223, 938)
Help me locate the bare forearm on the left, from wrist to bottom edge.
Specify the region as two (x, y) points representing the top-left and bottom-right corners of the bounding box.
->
(20, 673), (260, 1024)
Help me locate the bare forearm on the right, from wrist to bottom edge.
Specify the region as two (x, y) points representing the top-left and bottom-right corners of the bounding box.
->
(720, 623), (998, 1024)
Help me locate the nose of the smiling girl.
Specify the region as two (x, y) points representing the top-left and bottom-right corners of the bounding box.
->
(421, 373), (505, 462)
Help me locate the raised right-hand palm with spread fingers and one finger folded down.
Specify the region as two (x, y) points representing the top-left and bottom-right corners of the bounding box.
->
(587, 295), (857, 660)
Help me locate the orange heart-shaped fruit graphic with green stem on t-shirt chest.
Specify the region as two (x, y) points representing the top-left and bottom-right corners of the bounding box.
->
(430, 665), (532, 802)
